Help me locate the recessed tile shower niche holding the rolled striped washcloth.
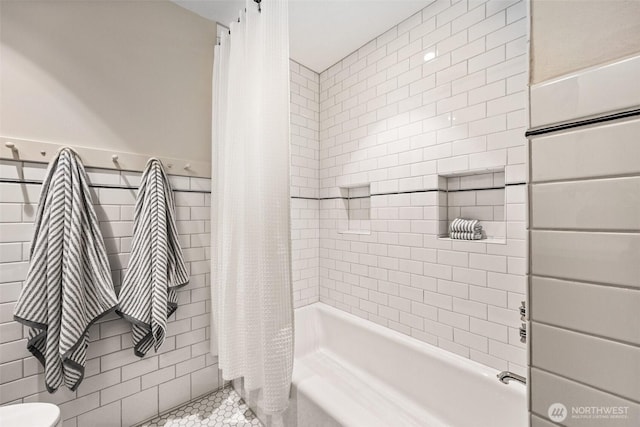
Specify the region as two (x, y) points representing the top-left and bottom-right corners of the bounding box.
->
(439, 169), (506, 244)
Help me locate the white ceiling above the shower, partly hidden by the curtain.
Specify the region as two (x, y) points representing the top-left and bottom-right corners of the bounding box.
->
(171, 0), (432, 73)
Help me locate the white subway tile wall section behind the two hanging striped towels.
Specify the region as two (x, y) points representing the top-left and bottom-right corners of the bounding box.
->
(0, 160), (219, 427)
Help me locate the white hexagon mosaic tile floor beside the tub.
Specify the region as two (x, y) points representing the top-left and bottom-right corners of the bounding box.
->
(139, 387), (262, 427)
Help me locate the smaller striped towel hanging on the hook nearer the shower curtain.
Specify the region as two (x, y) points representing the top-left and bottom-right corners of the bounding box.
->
(118, 159), (189, 357)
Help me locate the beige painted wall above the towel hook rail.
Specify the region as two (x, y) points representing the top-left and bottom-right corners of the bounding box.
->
(0, 0), (216, 160)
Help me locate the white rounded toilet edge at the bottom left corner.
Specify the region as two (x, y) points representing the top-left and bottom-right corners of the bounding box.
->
(0, 403), (62, 427)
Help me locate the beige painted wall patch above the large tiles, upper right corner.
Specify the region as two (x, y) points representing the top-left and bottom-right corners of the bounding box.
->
(531, 0), (640, 83)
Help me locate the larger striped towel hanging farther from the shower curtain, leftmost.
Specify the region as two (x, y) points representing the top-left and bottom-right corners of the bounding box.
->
(14, 148), (117, 393)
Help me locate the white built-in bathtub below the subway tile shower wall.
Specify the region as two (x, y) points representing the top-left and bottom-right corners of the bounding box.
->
(285, 303), (527, 427)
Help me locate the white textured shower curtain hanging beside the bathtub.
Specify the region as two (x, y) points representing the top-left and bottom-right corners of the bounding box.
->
(211, 0), (293, 413)
